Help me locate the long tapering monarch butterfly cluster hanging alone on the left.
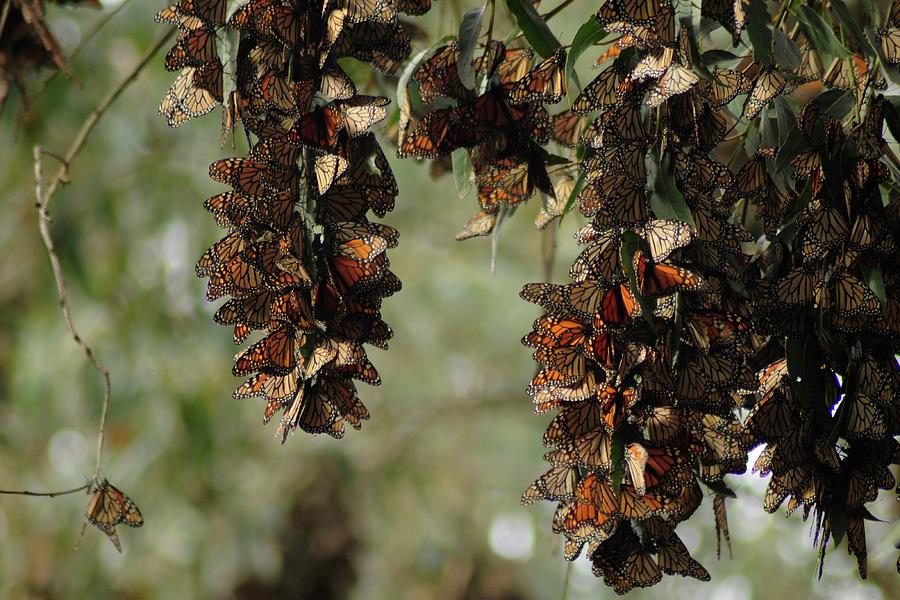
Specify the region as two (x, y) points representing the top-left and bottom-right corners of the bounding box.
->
(159, 0), (422, 440)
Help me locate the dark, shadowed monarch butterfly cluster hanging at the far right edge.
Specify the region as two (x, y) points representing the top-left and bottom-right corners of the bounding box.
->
(745, 95), (900, 577)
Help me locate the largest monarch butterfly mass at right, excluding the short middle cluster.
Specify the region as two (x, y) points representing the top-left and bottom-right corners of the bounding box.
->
(512, 0), (900, 593)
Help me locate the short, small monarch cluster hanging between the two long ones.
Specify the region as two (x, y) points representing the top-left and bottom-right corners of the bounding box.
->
(398, 40), (566, 239)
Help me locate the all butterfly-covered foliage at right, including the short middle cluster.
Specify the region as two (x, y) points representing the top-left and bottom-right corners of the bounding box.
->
(390, 0), (900, 593)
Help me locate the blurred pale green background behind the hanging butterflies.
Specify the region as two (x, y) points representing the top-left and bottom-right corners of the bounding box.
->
(0, 0), (900, 600)
